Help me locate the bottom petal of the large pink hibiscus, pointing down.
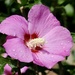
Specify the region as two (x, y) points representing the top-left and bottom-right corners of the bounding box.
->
(33, 51), (64, 69)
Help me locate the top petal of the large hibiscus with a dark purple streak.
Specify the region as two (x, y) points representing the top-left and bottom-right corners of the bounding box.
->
(28, 4), (60, 37)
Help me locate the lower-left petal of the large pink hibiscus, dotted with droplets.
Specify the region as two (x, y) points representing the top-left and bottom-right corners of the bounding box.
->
(3, 38), (33, 62)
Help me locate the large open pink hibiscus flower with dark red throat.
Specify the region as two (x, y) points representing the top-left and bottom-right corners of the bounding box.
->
(0, 4), (72, 68)
